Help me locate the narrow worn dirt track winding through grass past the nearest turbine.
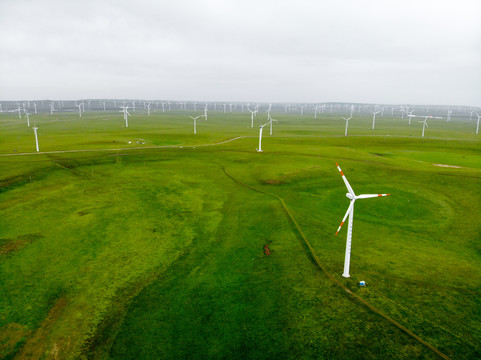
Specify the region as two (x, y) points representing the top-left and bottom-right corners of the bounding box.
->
(223, 167), (450, 360)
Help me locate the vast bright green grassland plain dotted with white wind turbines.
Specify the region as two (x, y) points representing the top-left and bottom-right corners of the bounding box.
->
(0, 111), (481, 359)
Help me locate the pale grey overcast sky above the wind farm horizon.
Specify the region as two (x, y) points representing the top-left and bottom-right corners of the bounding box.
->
(0, 0), (481, 106)
